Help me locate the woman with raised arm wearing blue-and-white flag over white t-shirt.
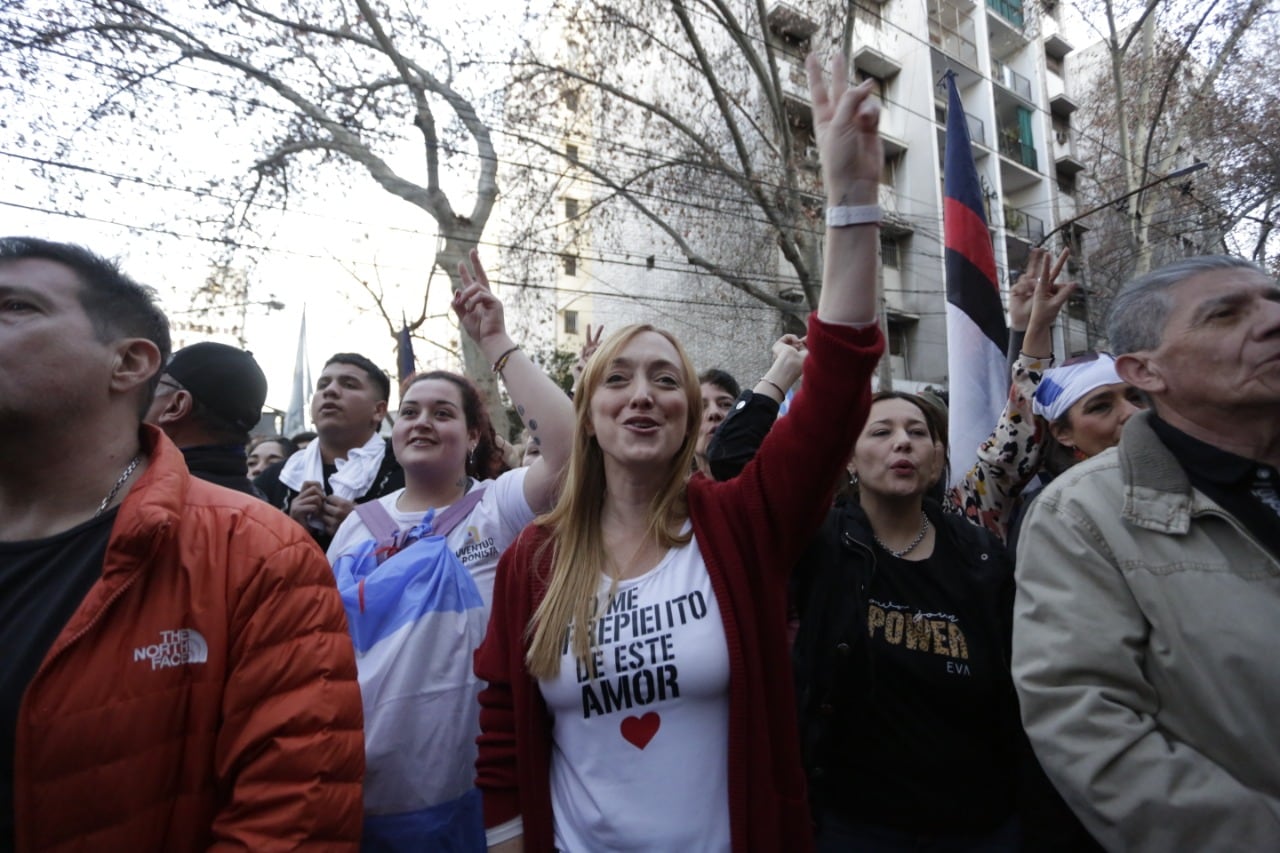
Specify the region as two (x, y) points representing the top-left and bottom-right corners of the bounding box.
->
(329, 251), (573, 852)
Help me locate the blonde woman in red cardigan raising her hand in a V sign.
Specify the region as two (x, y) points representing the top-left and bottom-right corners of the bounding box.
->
(476, 56), (883, 853)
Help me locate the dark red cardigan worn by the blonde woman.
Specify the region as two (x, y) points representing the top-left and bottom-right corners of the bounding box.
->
(475, 315), (884, 853)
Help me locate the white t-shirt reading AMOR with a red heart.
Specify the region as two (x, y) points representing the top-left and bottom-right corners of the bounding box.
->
(539, 532), (730, 853)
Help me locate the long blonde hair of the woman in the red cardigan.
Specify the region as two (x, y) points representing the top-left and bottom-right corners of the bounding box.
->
(525, 324), (703, 679)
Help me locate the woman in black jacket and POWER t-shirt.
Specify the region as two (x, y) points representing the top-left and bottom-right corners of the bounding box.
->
(795, 392), (1021, 850)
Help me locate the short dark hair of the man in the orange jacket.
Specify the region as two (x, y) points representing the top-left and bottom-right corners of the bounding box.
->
(0, 237), (172, 366)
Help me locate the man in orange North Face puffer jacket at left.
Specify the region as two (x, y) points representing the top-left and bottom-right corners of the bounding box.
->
(0, 238), (364, 852)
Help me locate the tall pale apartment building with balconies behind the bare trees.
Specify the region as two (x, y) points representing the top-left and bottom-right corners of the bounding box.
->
(509, 0), (1084, 389)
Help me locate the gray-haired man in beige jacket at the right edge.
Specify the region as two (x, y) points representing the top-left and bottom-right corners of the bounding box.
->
(1014, 256), (1280, 852)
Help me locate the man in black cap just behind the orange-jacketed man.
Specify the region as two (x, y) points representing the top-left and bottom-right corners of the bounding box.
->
(145, 342), (266, 497)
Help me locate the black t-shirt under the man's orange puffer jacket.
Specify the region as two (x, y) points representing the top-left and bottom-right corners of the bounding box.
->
(0, 510), (116, 850)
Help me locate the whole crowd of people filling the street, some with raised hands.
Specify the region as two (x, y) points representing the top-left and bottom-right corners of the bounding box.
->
(0, 55), (1280, 853)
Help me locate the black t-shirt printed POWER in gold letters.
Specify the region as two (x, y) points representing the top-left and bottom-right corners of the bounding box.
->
(827, 538), (1014, 835)
